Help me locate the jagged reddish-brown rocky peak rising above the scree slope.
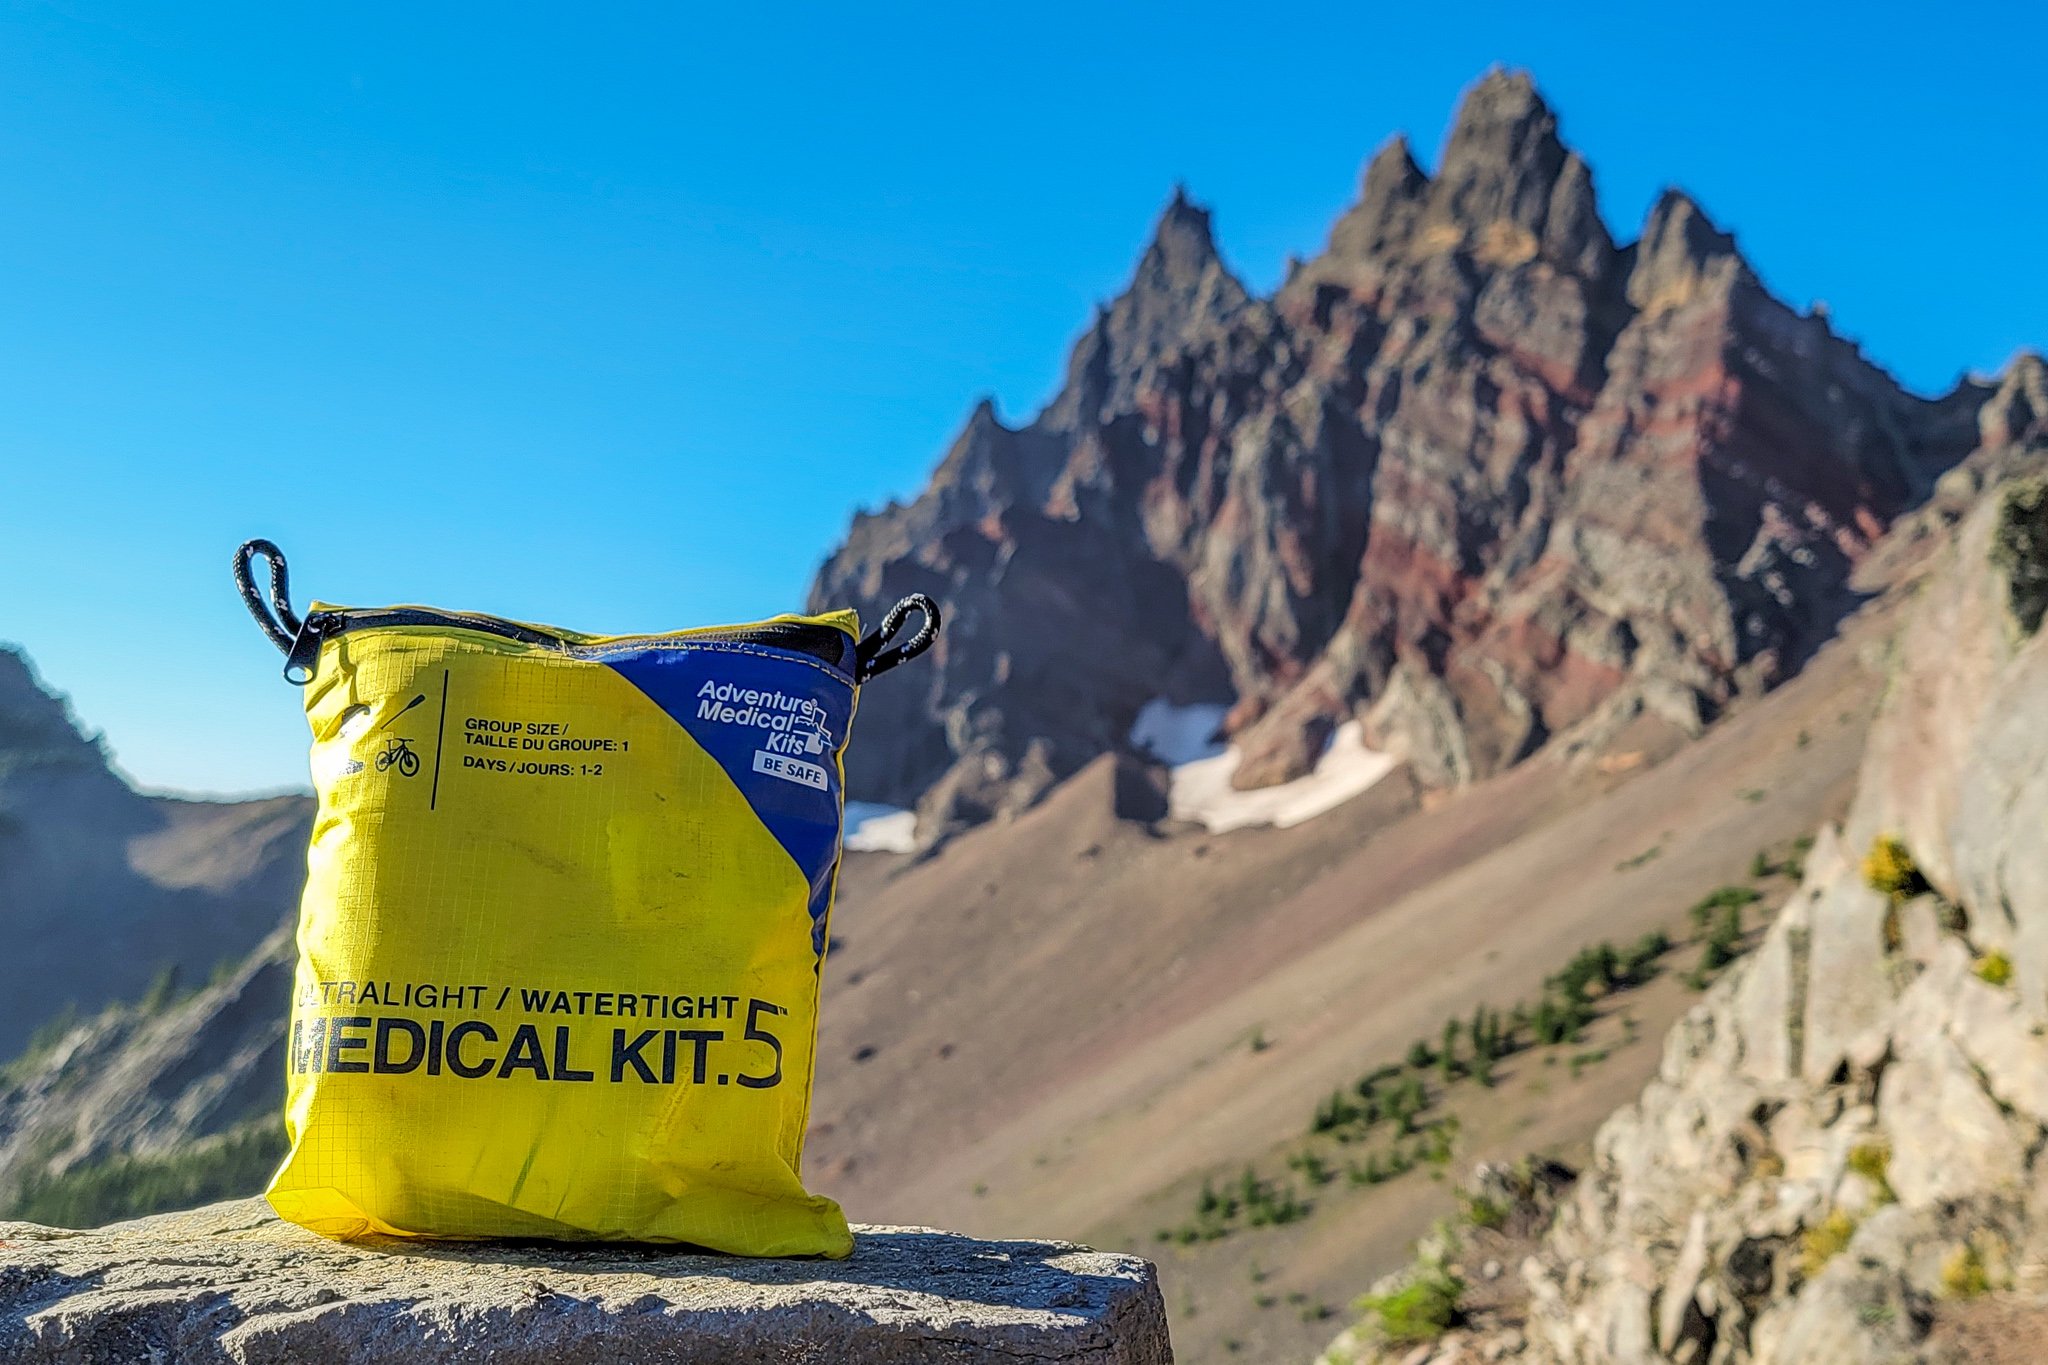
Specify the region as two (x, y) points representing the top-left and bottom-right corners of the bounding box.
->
(813, 72), (1998, 837)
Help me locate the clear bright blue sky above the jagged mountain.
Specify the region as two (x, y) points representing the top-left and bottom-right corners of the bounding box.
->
(0, 0), (2048, 792)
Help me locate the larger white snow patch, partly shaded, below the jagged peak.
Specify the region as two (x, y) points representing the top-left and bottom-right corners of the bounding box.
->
(1130, 698), (1399, 835)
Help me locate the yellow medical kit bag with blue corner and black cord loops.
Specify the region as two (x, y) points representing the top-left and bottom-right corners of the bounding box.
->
(236, 540), (938, 1257)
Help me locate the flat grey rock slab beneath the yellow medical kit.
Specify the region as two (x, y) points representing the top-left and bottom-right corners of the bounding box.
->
(0, 1199), (1174, 1365)
